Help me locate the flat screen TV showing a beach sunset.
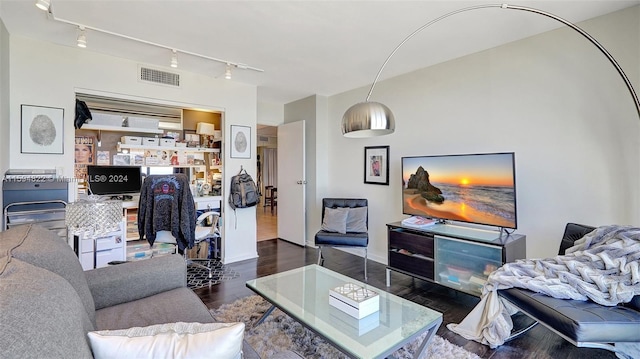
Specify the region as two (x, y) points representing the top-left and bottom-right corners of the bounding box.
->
(402, 152), (517, 229)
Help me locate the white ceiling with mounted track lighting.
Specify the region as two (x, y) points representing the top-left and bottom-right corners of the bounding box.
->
(0, 0), (640, 104)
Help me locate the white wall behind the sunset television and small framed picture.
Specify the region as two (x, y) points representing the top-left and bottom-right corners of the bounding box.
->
(318, 6), (640, 263)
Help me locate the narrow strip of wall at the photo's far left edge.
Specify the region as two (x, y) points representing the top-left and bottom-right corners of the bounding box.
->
(0, 20), (10, 208)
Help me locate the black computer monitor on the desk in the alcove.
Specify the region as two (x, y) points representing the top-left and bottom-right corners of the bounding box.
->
(87, 165), (142, 195)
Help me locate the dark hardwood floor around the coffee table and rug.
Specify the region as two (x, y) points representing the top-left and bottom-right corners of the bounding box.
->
(195, 239), (616, 359)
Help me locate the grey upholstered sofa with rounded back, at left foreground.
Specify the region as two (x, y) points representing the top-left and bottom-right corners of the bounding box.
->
(0, 225), (259, 358)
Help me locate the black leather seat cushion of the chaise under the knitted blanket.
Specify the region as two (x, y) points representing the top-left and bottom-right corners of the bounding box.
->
(498, 288), (640, 343)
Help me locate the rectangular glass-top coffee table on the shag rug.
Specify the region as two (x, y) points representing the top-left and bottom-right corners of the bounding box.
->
(246, 264), (442, 358)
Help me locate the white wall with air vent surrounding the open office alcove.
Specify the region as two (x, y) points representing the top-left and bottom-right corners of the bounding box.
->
(3, 37), (257, 262)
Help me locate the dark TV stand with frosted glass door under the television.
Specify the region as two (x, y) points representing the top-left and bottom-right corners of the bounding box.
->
(386, 222), (526, 296)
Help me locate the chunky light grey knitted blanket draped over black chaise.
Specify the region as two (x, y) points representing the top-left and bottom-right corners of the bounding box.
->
(447, 226), (640, 348)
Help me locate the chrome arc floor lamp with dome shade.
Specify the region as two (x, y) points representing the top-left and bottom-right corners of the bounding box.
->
(342, 4), (640, 138)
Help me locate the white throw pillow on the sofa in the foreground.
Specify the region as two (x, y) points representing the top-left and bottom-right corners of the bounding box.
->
(88, 322), (244, 359)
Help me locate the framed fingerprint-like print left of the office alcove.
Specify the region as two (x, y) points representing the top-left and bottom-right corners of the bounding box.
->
(20, 105), (64, 154)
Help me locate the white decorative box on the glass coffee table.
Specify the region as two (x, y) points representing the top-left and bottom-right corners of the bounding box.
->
(329, 283), (380, 319)
